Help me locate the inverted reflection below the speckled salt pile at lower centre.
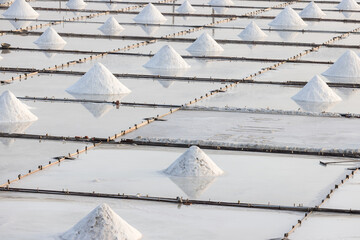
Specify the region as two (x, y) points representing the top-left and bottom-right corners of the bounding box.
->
(169, 176), (216, 198)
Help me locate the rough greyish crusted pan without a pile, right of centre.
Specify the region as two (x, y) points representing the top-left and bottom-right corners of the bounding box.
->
(129, 111), (360, 149)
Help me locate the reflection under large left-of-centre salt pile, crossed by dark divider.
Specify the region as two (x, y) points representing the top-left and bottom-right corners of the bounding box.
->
(69, 93), (128, 118)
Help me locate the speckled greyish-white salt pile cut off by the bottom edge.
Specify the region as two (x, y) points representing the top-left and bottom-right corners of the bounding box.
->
(60, 204), (142, 240)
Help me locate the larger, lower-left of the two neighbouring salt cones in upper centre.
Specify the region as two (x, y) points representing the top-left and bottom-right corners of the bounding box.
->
(144, 45), (190, 69)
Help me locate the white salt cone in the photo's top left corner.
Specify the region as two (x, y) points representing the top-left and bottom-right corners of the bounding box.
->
(3, 0), (39, 19)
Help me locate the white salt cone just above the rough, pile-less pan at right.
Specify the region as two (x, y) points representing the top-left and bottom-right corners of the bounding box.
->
(292, 75), (341, 102)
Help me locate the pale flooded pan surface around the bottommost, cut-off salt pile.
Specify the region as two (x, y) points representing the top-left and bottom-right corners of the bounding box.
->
(0, 193), (302, 240)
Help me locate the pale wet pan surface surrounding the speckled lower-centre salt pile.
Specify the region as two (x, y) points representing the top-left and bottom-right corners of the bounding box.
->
(14, 145), (348, 205)
